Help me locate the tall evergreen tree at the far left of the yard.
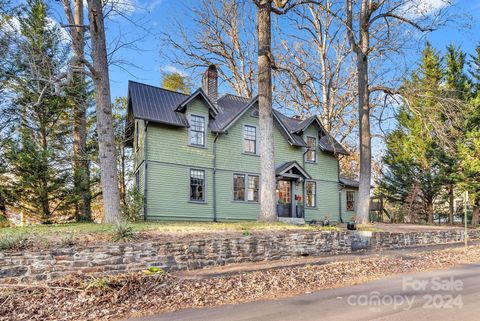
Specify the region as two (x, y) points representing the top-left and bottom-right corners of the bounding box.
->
(2, 0), (72, 222)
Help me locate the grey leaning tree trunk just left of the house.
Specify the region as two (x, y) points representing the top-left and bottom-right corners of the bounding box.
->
(88, 0), (121, 223)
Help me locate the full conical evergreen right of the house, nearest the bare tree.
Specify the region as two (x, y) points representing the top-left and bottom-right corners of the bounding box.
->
(383, 43), (443, 223)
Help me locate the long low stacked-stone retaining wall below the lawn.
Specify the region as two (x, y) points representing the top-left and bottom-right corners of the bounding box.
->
(0, 230), (480, 282)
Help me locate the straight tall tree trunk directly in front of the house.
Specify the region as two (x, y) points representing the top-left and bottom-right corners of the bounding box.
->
(258, 0), (277, 221)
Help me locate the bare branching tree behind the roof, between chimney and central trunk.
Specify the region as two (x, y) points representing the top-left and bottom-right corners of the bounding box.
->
(161, 0), (256, 97)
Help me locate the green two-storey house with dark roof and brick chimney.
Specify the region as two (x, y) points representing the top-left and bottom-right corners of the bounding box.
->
(125, 65), (358, 221)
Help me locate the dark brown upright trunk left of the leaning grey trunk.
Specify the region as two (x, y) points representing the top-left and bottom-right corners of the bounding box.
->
(67, 0), (91, 221)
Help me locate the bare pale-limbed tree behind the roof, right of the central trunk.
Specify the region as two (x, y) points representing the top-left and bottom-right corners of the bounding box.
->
(276, 0), (357, 142)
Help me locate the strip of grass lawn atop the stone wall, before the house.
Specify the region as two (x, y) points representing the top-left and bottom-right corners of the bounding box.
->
(0, 221), (341, 250)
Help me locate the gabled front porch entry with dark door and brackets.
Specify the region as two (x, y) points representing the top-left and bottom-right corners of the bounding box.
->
(275, 161), (311, 224)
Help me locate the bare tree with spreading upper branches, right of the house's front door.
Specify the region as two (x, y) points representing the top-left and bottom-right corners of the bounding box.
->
(345, 0), (450, 223)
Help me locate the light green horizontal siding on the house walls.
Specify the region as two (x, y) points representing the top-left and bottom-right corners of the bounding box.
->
(141, 100), (339, 221)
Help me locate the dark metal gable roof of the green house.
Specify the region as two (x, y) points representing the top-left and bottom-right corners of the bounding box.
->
(127, 81), (348, 154)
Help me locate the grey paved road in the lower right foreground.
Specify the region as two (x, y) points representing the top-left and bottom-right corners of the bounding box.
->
(130, 264), (480, 321)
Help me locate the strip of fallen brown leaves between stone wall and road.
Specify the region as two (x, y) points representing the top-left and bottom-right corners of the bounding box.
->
(0, 246), (480, 321)
